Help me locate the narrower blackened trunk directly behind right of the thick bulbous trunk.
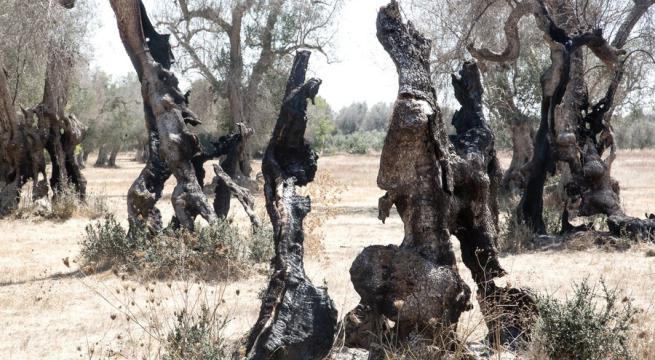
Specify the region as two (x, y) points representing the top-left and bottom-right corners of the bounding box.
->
(450, 63), (537, 346)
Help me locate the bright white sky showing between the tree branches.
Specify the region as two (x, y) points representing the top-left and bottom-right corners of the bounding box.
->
(91, 0), (398, 110)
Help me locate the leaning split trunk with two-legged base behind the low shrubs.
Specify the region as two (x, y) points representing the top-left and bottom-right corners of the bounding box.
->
(110, 0), (216, 230)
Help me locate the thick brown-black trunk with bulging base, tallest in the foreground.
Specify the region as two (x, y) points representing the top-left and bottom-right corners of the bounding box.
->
(346, 1), (471, 348)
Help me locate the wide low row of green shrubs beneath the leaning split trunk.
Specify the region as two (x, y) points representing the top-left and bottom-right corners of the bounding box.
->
(80, 215), (272, 279)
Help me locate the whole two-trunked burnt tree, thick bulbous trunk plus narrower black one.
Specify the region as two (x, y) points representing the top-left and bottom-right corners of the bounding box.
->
(346, 1), (535, 351)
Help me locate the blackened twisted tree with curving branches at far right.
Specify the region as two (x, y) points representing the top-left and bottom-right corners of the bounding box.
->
(469, 0), (655, 236)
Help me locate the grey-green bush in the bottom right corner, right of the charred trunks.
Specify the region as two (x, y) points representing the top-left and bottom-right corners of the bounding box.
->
(533, 280), (636, 360)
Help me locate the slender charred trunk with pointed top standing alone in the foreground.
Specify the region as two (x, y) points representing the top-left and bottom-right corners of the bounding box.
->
(245, 51), (337, 360)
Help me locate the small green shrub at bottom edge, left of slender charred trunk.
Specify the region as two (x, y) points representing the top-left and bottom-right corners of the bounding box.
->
(163, 304), (229, 360)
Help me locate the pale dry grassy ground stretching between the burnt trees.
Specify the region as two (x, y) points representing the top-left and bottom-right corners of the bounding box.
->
(0, 151), (655, 359)
